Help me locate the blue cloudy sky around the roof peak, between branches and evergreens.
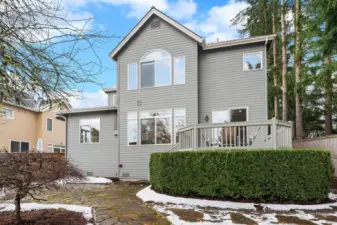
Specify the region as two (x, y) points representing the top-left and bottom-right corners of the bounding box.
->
(67, 0), (247, 108)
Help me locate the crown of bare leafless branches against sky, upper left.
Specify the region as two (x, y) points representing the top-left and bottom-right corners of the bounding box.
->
(0, 0), (113, 103)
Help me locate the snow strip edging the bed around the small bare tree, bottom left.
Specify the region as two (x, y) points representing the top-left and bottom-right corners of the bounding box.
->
(0, 203), (93, 225)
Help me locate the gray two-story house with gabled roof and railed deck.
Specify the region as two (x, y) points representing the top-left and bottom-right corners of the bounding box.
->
(65, 8), (291, 179)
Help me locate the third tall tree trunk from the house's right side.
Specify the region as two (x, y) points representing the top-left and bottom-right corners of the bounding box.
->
(294, 0), (303, 140)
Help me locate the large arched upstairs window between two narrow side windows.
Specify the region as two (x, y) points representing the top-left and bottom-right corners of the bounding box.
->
(140, 50), (172, 88)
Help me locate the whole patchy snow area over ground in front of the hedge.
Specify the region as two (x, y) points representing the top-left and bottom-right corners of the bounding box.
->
(137, 187), (337, 225)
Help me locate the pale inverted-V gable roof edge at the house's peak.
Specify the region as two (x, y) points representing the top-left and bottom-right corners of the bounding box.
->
(110, 7), (204, 59)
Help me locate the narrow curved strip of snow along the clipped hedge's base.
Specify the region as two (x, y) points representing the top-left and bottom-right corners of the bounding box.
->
(137, 186), (337, 211)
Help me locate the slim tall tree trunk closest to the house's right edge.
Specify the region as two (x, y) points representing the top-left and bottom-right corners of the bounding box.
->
(272, 0), (279, 119)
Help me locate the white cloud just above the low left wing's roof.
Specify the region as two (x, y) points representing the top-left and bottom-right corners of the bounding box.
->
(69, 90), (108, 108)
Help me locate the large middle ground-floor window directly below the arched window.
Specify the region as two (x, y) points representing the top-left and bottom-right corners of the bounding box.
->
(139, 109), (172, 145)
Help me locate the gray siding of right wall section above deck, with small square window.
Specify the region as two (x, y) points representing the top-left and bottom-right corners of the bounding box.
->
(199, 43), (268, 123)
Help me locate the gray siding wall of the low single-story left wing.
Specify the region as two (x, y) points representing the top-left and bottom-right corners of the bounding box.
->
(67, 111), (118, 177)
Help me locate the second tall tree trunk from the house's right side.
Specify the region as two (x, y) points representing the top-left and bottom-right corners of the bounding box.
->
(281, 0), (288, 121)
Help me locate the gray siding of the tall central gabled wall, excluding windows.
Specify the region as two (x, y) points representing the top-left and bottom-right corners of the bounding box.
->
(117, 14), (198, 179)
